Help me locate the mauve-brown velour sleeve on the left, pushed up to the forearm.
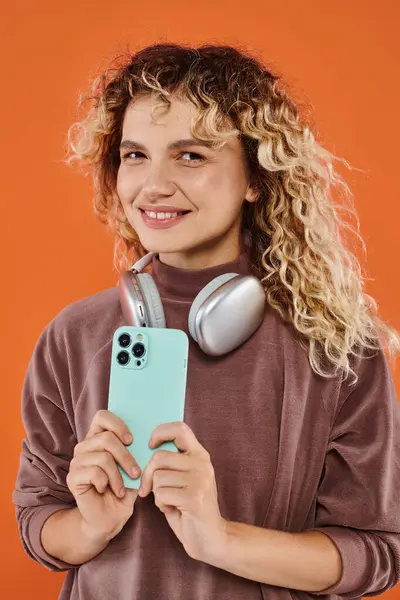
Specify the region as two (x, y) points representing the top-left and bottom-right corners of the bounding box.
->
(13, 328), (77, 571)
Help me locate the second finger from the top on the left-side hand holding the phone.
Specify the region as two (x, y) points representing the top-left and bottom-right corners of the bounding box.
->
(74, 431), (141, 479)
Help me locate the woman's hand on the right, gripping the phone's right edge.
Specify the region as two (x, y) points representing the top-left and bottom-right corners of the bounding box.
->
(139, 423), (226, 562)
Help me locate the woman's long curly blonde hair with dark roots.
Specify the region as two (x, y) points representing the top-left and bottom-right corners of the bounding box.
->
(68, 44), (400, 384)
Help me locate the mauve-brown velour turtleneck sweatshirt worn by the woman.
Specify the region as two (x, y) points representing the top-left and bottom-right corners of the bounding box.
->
(13, 256), (400, 600)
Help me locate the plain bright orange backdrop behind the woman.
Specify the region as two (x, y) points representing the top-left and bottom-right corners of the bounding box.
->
(0, 0), (400, 600)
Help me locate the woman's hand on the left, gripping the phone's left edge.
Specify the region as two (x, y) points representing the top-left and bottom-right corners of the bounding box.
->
(67, 410), (140, 541)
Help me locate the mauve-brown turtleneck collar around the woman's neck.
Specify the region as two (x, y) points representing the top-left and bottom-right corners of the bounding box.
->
(151, 252), (252, 302)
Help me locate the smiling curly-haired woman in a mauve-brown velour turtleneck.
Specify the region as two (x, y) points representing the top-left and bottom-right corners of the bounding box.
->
(14, 45), (400, 600)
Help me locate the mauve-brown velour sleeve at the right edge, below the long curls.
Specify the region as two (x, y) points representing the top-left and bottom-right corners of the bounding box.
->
(315, 349), (400, 598)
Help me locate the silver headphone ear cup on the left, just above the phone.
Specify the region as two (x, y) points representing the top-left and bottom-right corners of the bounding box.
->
(119, 271), (165, 327)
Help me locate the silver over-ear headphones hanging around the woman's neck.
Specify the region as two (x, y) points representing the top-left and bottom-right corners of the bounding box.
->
(119, 252), (265, 356)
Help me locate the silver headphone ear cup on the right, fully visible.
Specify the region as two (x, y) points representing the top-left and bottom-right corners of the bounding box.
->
(189, 273), (265, 356)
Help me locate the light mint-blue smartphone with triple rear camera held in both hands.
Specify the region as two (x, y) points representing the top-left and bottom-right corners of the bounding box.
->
(108, 325), (189, 489)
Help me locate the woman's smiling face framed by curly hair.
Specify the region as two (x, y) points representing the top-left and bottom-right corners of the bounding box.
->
(117, 96), (255, 269)
